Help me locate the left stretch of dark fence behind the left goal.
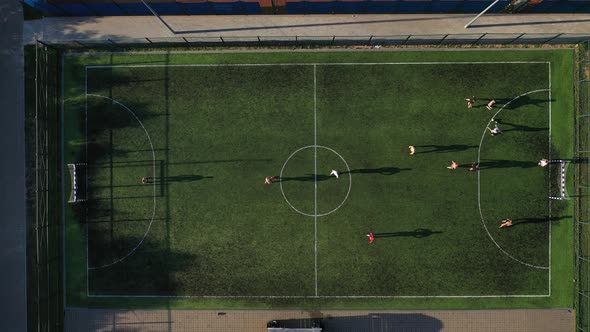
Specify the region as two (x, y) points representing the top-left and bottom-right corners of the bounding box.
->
(25, 43), (64, 331)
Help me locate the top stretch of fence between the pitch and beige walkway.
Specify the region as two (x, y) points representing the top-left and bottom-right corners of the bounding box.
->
(38, 31), (590, 50)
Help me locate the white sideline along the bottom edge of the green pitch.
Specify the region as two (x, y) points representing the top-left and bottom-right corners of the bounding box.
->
(89, 294), (550, 299)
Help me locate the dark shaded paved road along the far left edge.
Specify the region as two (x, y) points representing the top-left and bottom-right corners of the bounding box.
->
(0, 0), (27, 331)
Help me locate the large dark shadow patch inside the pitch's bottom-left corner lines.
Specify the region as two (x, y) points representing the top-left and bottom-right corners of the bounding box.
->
(88, 232), (200, 294)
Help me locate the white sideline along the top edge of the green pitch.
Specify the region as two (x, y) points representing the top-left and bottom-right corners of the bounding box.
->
(86, 61), (549, 69)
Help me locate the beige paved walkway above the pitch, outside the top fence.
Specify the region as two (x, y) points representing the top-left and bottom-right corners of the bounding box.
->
(23, 14), (590, 43)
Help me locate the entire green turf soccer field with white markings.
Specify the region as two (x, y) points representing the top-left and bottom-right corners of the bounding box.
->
(64, 50), (573, 308)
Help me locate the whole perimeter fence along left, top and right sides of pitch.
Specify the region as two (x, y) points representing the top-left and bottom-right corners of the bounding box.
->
(33, 33), (590, 332)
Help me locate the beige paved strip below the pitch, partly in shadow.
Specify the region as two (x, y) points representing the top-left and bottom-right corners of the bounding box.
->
(65, 309), (575, 332)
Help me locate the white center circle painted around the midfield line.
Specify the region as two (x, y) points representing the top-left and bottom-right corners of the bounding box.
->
(279, 145), (352, 217)
